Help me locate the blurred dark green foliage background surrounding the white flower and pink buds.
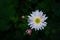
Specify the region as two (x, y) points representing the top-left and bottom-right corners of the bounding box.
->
(0, 0), (60, 40)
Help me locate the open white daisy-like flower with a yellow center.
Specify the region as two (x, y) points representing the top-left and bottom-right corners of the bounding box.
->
(28, 10), (48, 30)
